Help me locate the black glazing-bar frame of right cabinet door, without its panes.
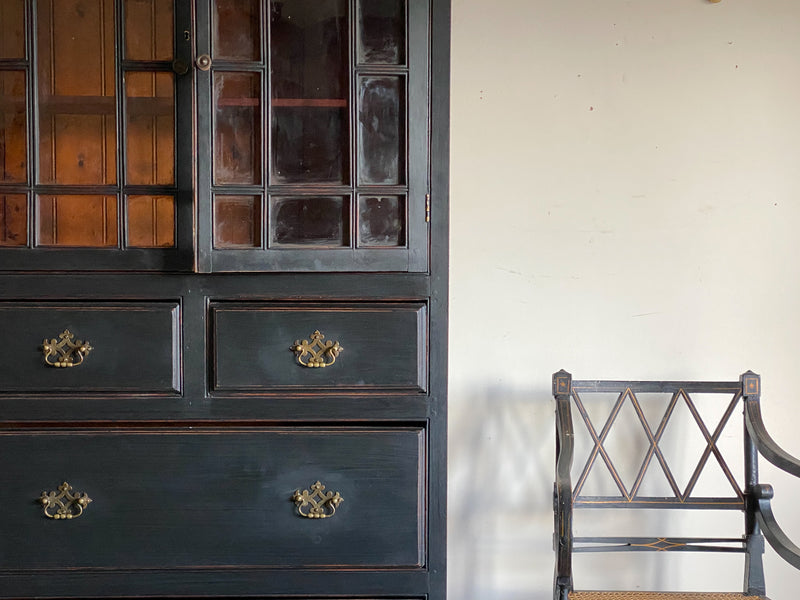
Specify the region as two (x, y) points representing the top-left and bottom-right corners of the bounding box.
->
(195, 0), (431, 272)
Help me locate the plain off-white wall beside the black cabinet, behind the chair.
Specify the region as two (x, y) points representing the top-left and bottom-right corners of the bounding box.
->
(449, 0), (800, 600)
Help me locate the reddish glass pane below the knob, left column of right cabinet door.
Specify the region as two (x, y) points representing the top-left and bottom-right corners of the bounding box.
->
(214, 71), (261, 185)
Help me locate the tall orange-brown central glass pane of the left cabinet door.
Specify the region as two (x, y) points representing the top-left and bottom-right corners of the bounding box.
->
(36, 0), (117, 185)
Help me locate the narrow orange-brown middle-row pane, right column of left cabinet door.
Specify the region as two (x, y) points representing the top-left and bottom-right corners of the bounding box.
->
(125, 71), (175, 185)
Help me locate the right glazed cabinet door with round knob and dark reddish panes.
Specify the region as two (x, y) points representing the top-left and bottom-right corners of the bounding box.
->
(196, 0), (429, 271)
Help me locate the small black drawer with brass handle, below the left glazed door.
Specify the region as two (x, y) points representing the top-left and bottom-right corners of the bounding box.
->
(0, 302), (181, 394)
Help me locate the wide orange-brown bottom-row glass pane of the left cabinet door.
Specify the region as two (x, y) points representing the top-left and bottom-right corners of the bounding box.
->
(37, 195), (117, 248)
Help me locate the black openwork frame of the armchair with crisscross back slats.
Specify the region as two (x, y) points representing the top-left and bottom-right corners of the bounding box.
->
(553, 370), (800, 600)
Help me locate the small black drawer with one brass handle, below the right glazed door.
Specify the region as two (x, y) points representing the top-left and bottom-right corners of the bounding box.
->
(211, 302), (428, 393)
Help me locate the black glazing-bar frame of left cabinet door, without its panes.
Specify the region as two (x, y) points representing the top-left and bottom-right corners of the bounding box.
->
(0, 0), (195, 271)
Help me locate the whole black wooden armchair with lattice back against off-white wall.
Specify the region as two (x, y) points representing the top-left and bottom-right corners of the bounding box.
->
(553, 370), (800, 600)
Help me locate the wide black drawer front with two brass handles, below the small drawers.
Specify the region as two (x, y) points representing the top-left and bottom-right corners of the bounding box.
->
(0, 427), (426, 574)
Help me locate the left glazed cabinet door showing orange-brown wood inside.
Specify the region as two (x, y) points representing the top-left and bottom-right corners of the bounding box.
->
(0, 0), (193, 270)
